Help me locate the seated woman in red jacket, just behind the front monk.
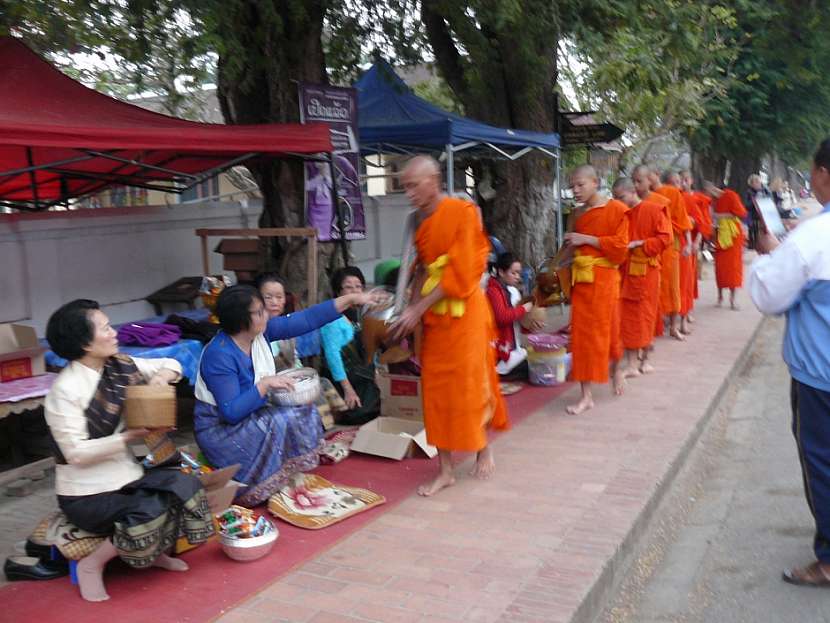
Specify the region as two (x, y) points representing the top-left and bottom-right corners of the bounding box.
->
(486, 252), (544, 379)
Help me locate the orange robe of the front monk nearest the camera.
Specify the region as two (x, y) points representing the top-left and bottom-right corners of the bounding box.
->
(415, 197), (509, 452)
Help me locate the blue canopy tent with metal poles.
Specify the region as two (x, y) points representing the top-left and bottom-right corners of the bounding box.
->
(354, 60), (562, 241)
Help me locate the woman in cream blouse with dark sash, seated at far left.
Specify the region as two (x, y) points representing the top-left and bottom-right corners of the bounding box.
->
(45, 299), (213, 601)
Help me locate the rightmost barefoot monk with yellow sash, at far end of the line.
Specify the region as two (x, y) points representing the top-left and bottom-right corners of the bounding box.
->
(703, 182), (747, 310)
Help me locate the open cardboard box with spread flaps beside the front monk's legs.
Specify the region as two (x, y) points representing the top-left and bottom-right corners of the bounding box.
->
(352, 417), (438, 461)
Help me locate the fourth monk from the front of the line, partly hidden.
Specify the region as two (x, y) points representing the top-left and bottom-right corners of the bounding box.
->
(651, 170), (692, 341)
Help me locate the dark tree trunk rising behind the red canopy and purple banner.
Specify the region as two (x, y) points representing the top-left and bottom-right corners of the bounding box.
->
(216, 0), (344, 298)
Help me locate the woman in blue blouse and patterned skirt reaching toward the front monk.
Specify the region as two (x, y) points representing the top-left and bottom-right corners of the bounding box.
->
(194, 285), (375, 506)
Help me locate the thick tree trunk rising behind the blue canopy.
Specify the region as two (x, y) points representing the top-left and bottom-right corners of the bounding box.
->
(421, 0), (558, 267)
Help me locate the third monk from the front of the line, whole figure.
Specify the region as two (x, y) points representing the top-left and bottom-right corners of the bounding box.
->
(612, 176), (672, 378)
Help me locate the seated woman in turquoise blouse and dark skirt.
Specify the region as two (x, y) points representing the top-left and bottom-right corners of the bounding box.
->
(320, 266), (380, 425)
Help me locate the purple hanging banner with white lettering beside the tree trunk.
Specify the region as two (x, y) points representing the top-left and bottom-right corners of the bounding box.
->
(300, 83), (366, 242)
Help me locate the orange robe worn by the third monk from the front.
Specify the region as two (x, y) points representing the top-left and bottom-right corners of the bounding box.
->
(620, 201), (672, 350)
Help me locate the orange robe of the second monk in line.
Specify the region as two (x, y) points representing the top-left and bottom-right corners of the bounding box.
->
(571, 199), (628, 383)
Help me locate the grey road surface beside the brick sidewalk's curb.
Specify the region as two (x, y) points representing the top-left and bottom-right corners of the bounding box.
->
(599, 319), (830, 623)
